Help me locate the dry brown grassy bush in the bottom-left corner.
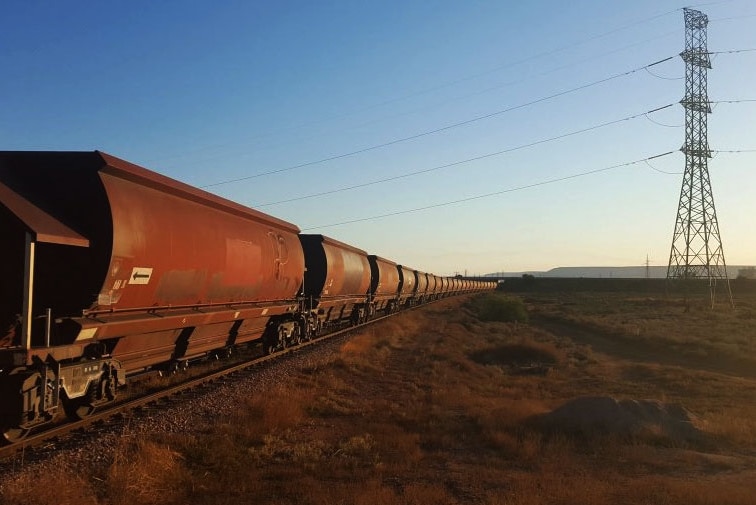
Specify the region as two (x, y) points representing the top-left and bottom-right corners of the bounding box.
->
(0, 468), (99, 505)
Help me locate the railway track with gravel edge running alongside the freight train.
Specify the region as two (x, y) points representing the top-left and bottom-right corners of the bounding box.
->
(0, 314), (390, 461)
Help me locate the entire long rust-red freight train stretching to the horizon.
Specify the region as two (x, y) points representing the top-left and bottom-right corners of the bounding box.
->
(0, 151), (495, 442)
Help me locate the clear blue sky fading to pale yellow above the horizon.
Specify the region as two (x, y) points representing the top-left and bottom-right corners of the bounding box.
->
(0, 0), (756, 275)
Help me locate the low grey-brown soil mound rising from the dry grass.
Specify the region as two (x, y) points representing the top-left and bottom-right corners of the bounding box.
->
(536, 396), (702, 441)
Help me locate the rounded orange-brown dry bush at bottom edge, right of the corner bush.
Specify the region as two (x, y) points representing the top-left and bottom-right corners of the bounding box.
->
(106, 440), (191, 505)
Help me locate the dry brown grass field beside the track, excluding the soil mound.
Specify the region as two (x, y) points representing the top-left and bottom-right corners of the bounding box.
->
(5, 295), (756, 505)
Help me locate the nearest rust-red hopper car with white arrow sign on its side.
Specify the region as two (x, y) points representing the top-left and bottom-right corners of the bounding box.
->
(0, 151), (304, 440)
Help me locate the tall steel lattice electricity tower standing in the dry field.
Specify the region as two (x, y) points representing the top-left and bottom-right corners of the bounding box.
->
(667, 8), (732, 306)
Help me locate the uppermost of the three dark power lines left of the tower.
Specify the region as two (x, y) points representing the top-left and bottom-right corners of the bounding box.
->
(200, 56), (675, 188)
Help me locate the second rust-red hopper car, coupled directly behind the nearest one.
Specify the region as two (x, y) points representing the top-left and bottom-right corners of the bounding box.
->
(299, 234), (372, 334)
